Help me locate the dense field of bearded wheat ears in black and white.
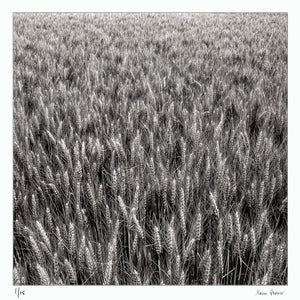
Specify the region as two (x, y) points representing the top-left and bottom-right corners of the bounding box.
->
(13, 13), (287, 285)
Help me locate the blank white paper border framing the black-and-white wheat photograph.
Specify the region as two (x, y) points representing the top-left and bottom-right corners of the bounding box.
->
(0, 0), (300, 300)
